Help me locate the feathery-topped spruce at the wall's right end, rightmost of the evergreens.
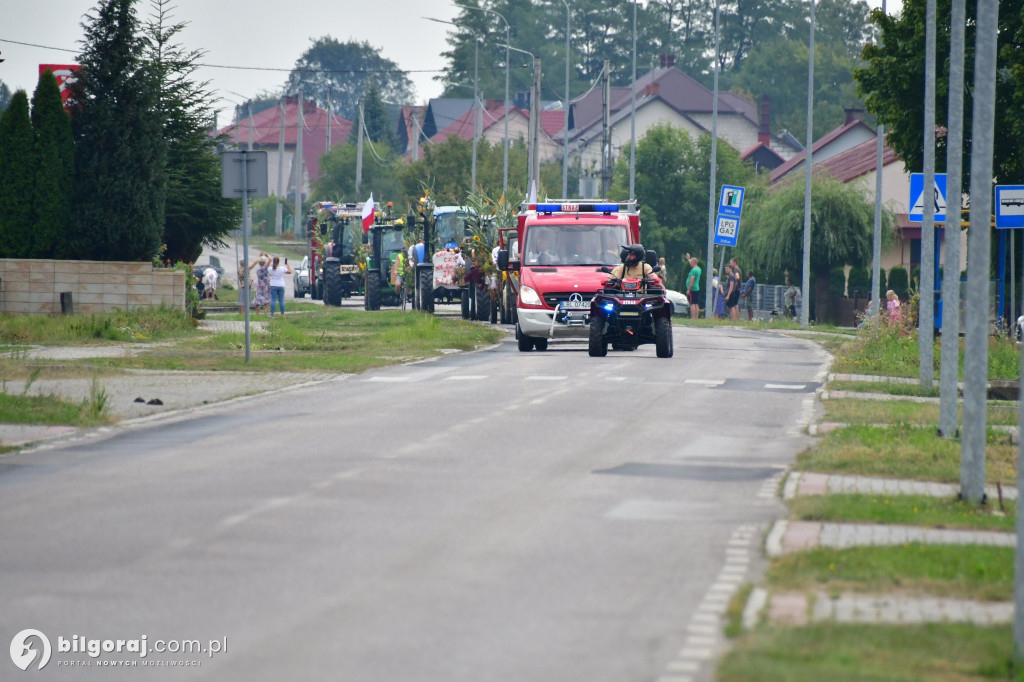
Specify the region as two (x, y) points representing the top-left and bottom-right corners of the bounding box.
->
(144, 0), (235, 262)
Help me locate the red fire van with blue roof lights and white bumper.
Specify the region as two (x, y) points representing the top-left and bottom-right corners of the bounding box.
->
(498, 201), (640, 351)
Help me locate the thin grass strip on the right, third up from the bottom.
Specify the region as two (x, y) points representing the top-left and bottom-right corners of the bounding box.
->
(790, 495), (1017, 532)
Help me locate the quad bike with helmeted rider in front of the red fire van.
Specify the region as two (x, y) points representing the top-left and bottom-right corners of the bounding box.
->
(589, 244), (673, 357)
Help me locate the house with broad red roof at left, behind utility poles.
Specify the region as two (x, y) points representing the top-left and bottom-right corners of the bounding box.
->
(216, 97), (352, 197)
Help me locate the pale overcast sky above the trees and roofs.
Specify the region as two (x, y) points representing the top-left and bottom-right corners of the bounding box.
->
(0, 0), (888, 125)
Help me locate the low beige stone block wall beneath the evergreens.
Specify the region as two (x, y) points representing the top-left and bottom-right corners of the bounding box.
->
(0, 258), (185, 314)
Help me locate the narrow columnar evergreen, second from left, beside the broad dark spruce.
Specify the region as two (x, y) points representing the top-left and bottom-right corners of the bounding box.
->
(31, 71), (75, 258)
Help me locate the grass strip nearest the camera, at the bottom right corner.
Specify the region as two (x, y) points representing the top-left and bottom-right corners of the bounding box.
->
(717, 624), (1024, 682)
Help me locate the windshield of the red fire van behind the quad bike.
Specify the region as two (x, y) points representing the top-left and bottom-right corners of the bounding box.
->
(522, 223), (629, 265)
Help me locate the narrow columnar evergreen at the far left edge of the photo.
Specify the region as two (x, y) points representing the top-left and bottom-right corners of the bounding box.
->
(0, 90), (35, 258)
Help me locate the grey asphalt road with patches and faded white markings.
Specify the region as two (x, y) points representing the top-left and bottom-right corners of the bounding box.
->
(0, 327), (826, 682)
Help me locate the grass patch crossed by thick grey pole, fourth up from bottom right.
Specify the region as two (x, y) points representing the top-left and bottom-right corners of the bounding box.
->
(796, 424), (1017, 484)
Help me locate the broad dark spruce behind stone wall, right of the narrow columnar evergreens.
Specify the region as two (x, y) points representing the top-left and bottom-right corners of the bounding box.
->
(72, 0), (167, 260)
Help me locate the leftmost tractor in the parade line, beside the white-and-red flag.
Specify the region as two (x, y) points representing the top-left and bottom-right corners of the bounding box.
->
(321, 202), (365, 305)
